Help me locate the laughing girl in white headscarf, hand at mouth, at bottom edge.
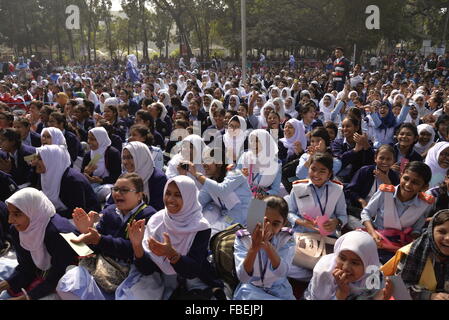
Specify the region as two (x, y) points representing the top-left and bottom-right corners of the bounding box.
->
(304, 231), (389, 300)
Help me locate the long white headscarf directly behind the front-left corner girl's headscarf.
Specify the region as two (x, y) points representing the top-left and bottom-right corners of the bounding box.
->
(37, 145), (70, 210)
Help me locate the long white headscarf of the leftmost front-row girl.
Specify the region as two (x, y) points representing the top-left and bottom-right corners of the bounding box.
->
(5, 188), (56, 271)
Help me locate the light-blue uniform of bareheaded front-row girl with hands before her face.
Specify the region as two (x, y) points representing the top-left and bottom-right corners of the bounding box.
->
(233, 228), (295, 300)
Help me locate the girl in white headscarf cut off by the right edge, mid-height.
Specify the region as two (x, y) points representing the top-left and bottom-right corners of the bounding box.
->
(425, 142), (449, 188)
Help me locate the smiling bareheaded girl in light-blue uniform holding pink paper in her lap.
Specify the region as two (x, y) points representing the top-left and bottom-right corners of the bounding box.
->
(288, 153), (348, 236)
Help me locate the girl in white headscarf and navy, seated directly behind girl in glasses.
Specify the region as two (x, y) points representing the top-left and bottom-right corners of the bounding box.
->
(122, 141), (167, 211)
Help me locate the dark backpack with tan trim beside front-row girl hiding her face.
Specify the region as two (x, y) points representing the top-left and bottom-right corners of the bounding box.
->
(210, 224), (245, 291)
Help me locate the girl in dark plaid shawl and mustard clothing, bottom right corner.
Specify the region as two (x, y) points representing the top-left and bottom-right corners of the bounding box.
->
(382, 209), (449, 300)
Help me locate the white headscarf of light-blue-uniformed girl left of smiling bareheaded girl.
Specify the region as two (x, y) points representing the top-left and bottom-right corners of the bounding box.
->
(239, 129), (279, 187)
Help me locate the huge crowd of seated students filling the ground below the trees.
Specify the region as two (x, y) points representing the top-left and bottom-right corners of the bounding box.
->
(0, 48), (449, 300)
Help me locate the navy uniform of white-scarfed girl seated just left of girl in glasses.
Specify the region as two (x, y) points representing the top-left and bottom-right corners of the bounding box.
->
(59, 168), (101, 219)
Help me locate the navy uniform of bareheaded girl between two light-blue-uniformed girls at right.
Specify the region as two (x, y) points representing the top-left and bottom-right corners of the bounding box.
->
(344, 165), (399, 207)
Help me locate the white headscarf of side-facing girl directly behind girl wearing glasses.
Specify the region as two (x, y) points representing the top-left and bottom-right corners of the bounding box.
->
(123, 141), (154, 200)
